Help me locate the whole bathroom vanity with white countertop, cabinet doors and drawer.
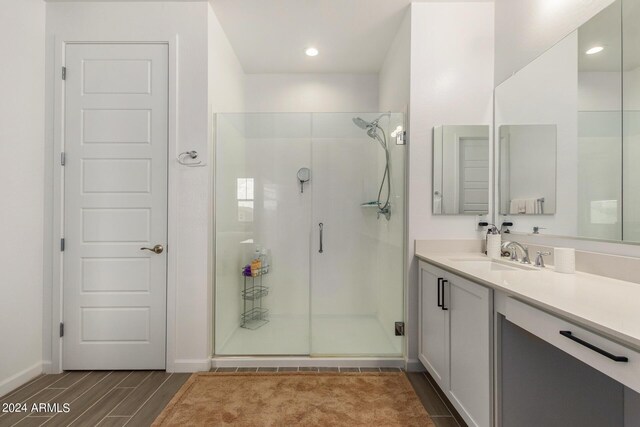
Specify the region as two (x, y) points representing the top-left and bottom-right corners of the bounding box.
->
(416, 251), (640, 427)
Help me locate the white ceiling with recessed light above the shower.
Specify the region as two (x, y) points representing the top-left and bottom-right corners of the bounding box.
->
(211, 0), (487, 73)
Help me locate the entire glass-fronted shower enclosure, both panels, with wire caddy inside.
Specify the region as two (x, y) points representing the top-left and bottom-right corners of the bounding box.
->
(214, 113), (406, 357)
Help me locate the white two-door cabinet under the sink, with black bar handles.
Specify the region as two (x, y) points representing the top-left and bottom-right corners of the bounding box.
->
(419, 262), (493, 426)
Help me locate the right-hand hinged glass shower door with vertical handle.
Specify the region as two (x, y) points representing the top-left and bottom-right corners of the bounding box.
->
(310, 113), (406, 356)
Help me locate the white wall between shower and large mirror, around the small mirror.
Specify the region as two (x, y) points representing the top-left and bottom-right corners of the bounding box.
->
(406, 3), (494, 363)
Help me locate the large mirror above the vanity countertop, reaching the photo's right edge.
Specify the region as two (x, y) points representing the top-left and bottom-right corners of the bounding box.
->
(494, 0), (640, 242)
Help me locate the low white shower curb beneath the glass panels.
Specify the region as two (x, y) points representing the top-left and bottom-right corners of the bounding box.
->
(211, 356), (404, 368)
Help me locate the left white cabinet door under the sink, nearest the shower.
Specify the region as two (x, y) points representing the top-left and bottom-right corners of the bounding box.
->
(419, 268), (448, 389)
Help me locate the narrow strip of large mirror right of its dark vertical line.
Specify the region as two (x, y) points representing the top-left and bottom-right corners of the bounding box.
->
(622, 0), (640, 243)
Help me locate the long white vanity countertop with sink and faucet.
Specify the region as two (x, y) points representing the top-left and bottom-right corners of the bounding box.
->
(416, 252), (640, 350)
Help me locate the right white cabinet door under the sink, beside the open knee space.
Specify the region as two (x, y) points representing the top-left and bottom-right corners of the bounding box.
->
(445, 276), (493, 426)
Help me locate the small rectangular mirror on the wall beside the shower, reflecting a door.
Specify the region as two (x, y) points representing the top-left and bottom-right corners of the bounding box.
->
(432, 125), (489, 215)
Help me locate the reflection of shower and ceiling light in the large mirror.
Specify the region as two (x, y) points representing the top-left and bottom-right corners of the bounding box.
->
(577, 1), (622, 240)
